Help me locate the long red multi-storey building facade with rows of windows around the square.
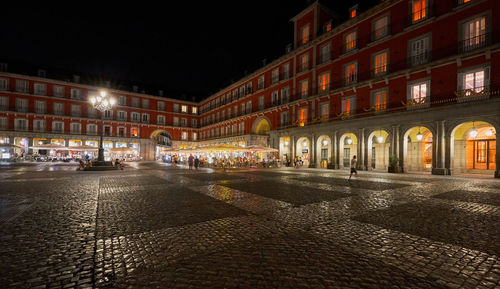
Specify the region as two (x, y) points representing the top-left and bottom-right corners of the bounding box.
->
(0, 0), (500, 175)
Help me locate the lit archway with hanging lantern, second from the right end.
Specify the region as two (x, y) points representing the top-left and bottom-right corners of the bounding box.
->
(403, 126), (433, 172)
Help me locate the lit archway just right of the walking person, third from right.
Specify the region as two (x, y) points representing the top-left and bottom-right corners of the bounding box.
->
(367, 129), (390, 171)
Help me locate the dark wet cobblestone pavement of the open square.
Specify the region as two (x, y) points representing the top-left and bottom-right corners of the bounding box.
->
(0, 163), (500, 288)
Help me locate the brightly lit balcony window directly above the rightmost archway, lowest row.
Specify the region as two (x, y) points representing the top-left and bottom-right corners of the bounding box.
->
(458, 66), (490, 96)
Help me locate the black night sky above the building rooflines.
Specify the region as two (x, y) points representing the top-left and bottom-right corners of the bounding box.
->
(0, 0), (375, 100)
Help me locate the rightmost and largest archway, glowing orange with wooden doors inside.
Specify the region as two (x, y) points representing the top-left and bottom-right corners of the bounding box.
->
(450, 121), (497, 174)
